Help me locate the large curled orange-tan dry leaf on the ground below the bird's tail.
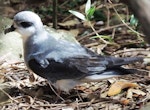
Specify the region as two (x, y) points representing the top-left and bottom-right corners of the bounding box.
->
(108, 81), (138, 96)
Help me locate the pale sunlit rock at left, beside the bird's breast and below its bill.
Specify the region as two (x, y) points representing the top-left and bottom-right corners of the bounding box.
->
(0, 16), (23, 62)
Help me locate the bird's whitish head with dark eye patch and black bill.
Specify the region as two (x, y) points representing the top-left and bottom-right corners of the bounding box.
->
(5, 11), (43, 37)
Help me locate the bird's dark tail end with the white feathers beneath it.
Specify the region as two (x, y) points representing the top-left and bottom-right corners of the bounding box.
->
(82, 57), (144, 82)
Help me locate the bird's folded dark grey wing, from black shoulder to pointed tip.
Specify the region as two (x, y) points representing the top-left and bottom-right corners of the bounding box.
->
(29, 56), (142, 82)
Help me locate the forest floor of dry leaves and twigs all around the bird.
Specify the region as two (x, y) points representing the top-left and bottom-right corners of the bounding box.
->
(0, 0), (150, 110)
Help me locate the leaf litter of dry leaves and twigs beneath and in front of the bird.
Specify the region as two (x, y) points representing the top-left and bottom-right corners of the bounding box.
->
(0, 49), (150, 110)
